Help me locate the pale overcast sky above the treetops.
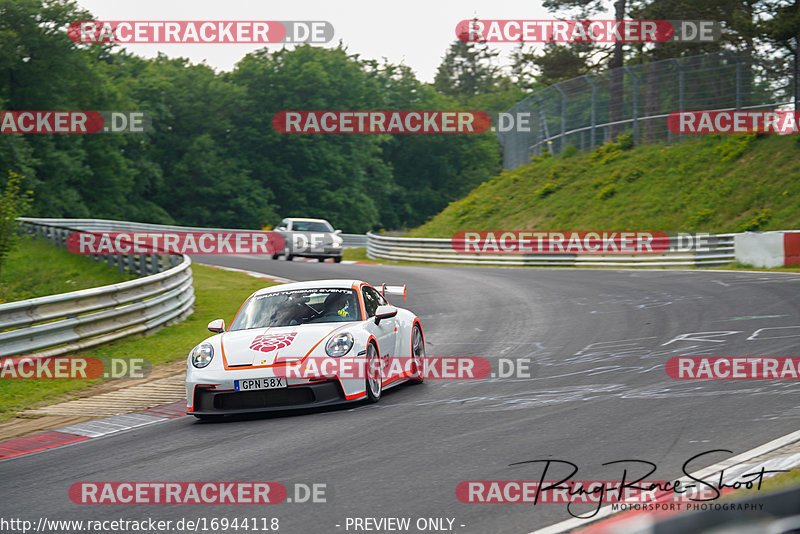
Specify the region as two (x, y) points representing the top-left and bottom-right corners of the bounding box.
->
(77, 0), (609, 82)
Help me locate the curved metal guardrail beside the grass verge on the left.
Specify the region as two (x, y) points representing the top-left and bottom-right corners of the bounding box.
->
(0, 219), (194, 358)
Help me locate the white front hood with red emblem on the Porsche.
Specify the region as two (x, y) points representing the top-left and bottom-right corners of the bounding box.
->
(220, 322), (352, 366)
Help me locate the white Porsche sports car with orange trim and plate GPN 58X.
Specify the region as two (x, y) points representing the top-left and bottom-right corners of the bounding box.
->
(186, 280), (425, 419)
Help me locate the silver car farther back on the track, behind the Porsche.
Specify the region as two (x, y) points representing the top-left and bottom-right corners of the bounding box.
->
(272, 218), (343, 263)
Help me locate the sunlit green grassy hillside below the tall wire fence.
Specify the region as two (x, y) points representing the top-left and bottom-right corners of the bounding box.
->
(410, 134), (800, 237)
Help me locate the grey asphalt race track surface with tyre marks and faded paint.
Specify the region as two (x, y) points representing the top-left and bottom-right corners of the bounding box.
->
(0, 256), (800, 534)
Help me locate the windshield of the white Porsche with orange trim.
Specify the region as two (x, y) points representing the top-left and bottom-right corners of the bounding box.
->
(230, 288), (361, 330)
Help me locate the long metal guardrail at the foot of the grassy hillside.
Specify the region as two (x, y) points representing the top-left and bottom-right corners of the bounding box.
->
(367, 233), (736, 267)
